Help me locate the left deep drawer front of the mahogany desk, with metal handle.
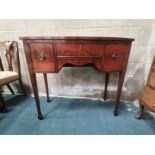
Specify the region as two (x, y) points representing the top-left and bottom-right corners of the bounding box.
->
(29, 42), (55, 72)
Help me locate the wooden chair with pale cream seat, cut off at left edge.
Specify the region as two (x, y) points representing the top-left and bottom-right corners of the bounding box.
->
(0, 41), (26, 111)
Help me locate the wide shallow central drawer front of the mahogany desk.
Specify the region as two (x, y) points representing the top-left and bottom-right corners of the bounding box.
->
(56, 43), (103, 57)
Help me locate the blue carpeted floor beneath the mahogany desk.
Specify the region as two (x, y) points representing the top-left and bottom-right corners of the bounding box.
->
(0, 95), (155, 135)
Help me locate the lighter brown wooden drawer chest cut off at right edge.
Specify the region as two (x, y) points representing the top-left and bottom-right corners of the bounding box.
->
(136, 57), (155, 119)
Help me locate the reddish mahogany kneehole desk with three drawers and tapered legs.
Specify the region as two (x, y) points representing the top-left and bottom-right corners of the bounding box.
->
(20, 36), (134, 119)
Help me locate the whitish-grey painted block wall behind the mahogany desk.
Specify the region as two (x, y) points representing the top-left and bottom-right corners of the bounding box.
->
(0, 19), (155, 100)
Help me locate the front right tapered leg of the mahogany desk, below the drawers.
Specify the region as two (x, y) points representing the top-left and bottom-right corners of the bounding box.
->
(113, 72), (124, 116)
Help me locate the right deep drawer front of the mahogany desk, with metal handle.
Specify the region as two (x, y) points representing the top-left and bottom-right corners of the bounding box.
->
(104, 43), (127, 71)
